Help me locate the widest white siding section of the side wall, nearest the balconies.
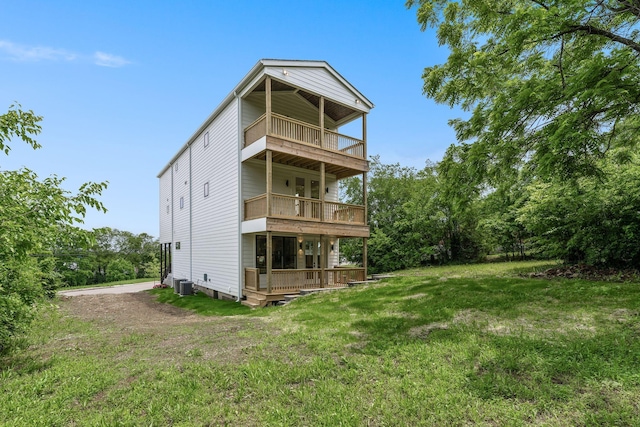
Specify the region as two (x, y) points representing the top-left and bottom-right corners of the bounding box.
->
(191, 101), (240, 296)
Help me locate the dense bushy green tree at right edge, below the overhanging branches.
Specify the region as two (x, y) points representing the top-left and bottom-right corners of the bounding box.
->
(517, 149), (640, 268)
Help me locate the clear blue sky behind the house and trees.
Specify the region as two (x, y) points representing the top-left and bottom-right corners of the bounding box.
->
(0, 0), (461, 236)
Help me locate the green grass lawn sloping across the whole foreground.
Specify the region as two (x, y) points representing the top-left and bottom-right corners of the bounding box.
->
(0, 262), (640, 426)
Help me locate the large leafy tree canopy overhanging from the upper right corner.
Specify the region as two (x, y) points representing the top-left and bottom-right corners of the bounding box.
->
(406, 0), (640, 185)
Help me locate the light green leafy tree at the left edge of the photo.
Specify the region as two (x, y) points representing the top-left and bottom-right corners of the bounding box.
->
(0, 106), (106, 353)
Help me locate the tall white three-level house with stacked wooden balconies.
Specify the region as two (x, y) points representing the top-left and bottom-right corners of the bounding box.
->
(158, 59), (373, 306)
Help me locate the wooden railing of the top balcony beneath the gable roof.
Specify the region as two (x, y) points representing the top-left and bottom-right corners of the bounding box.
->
(244, 113), (364, 159)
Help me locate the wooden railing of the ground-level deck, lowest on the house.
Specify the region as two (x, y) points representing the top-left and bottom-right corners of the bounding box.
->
(245, 268), (365, 292)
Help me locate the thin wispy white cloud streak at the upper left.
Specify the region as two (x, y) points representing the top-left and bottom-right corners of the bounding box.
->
(0, 40), (131, 68)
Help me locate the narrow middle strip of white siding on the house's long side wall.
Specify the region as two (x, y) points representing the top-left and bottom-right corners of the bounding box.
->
(170, 149), (191, 279)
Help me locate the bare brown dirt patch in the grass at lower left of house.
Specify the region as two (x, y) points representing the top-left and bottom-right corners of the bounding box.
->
(60, 292), (277, 363)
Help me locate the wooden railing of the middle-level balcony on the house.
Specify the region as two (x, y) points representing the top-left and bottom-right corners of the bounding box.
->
(244, 194), (365, 225)
